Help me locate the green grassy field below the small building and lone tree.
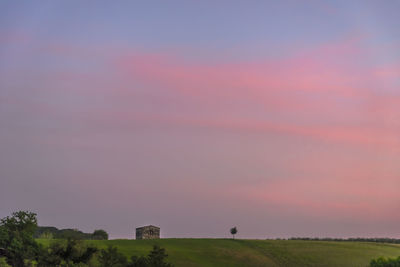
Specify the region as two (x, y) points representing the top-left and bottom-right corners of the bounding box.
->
(40, 239), (400, 266)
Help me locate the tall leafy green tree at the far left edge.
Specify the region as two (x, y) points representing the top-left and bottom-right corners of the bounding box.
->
(0, 211), (38, 267)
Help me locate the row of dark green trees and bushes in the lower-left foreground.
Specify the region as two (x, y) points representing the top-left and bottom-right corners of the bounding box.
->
(0, 211), (172, 267)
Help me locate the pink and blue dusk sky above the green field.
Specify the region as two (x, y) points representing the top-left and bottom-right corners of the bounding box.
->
(0, 0), (400, 239)
